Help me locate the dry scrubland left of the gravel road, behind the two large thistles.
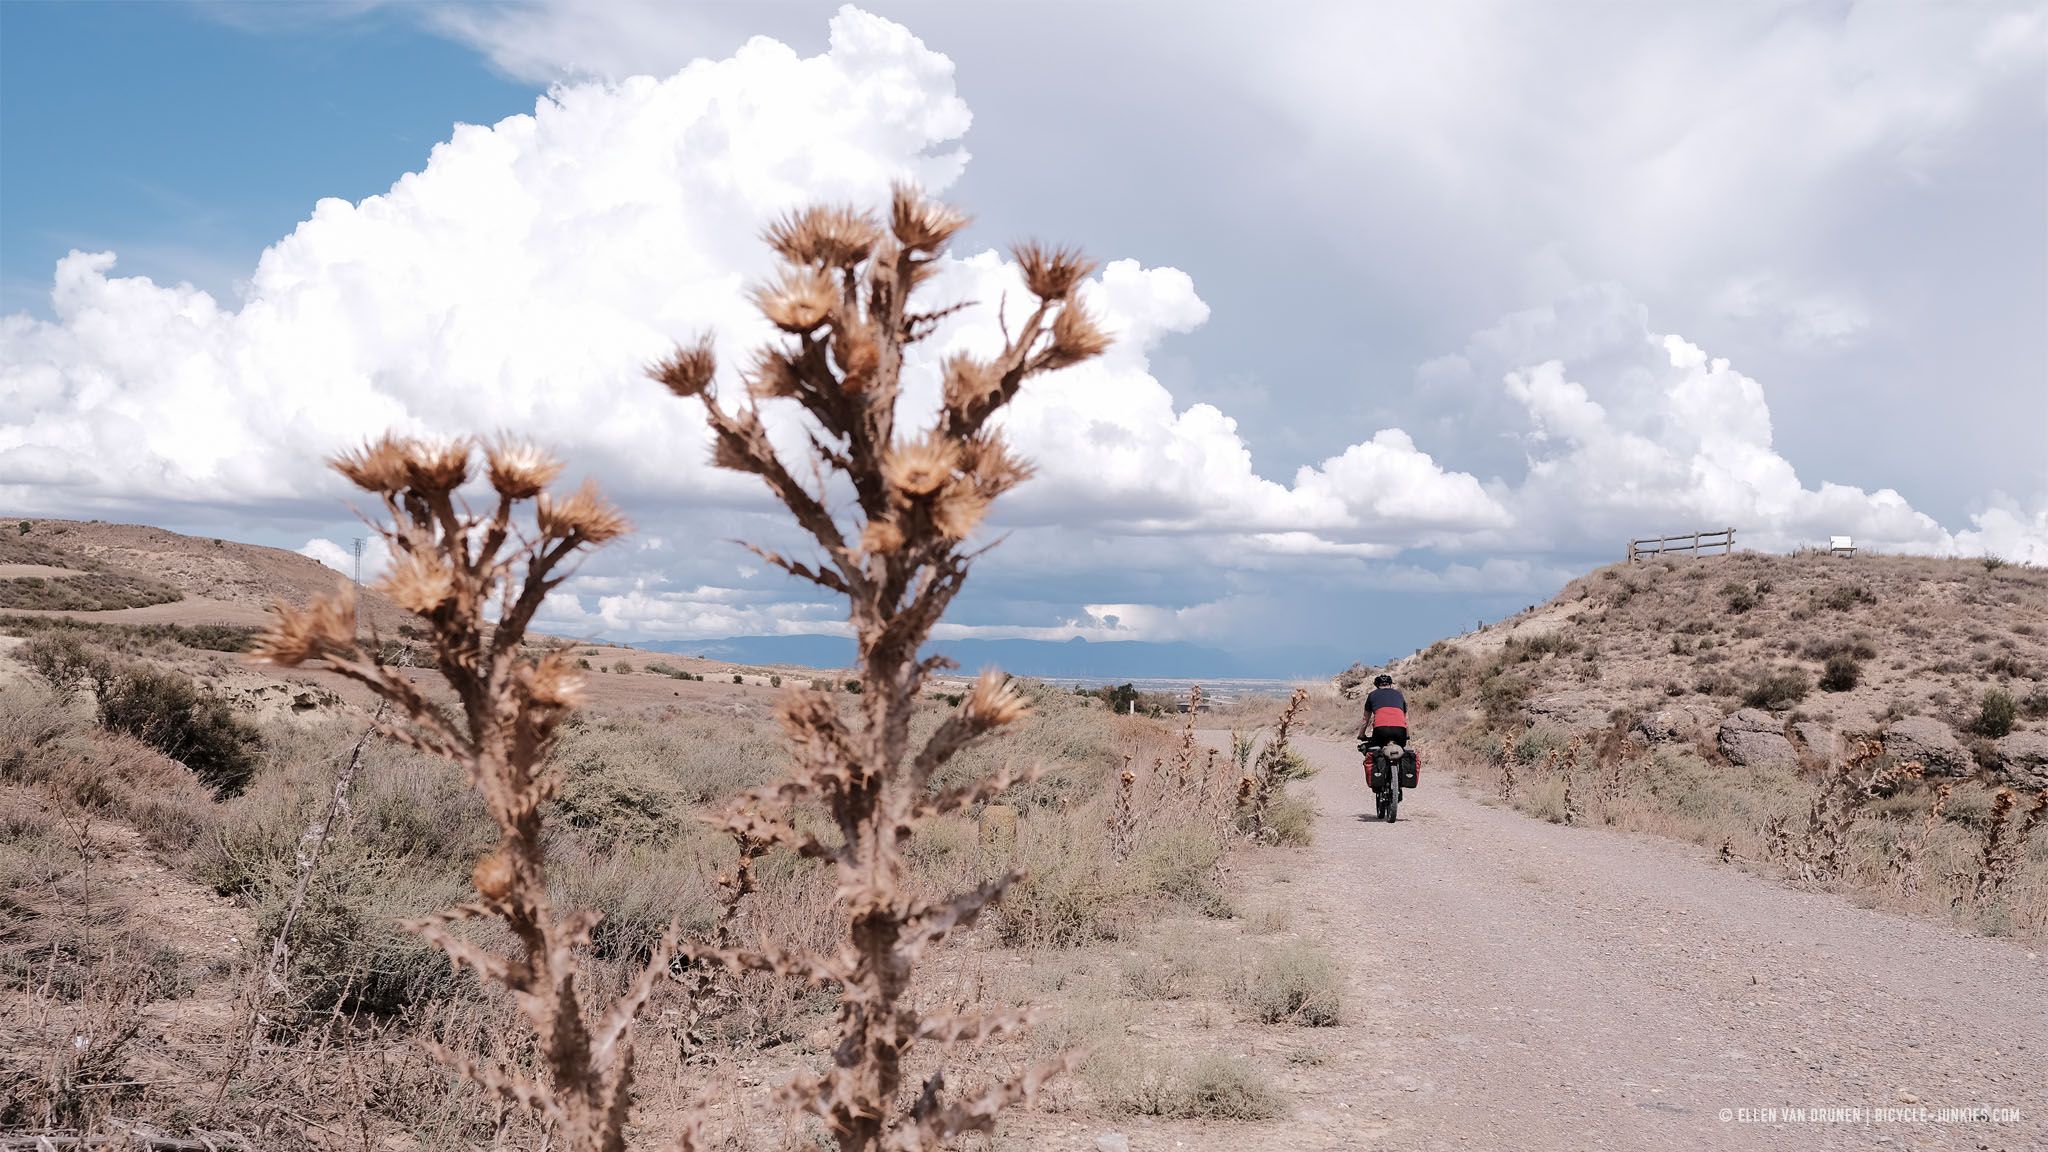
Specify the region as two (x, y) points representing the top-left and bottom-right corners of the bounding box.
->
(0, 521), (1341, 1150)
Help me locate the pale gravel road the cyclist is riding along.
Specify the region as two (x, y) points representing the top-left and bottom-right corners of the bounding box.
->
(1171, 740), (2048, 1152)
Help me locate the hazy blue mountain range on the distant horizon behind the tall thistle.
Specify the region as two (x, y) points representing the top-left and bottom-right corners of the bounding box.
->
(633, 635), (1350, 681)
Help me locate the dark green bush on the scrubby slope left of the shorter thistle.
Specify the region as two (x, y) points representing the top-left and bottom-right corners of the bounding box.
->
(94, 664), (258, 795)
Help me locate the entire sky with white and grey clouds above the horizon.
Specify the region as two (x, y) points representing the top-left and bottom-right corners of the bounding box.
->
(0, 0), (2048, 674)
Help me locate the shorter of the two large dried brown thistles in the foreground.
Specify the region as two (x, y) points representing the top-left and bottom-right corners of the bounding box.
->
(256, 437), (674, 1152)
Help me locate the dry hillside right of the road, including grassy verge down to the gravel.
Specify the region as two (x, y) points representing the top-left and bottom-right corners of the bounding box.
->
(1359, 553), (2048, 939)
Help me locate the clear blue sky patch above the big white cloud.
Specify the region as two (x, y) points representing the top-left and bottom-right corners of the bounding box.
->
(0, 2), (543, 316)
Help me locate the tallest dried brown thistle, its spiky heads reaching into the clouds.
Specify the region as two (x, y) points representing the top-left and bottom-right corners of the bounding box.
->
(649, 189), (1110, 1152)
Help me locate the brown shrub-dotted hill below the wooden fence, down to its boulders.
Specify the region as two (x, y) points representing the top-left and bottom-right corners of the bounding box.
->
(1397, 553), (2048, 787)
